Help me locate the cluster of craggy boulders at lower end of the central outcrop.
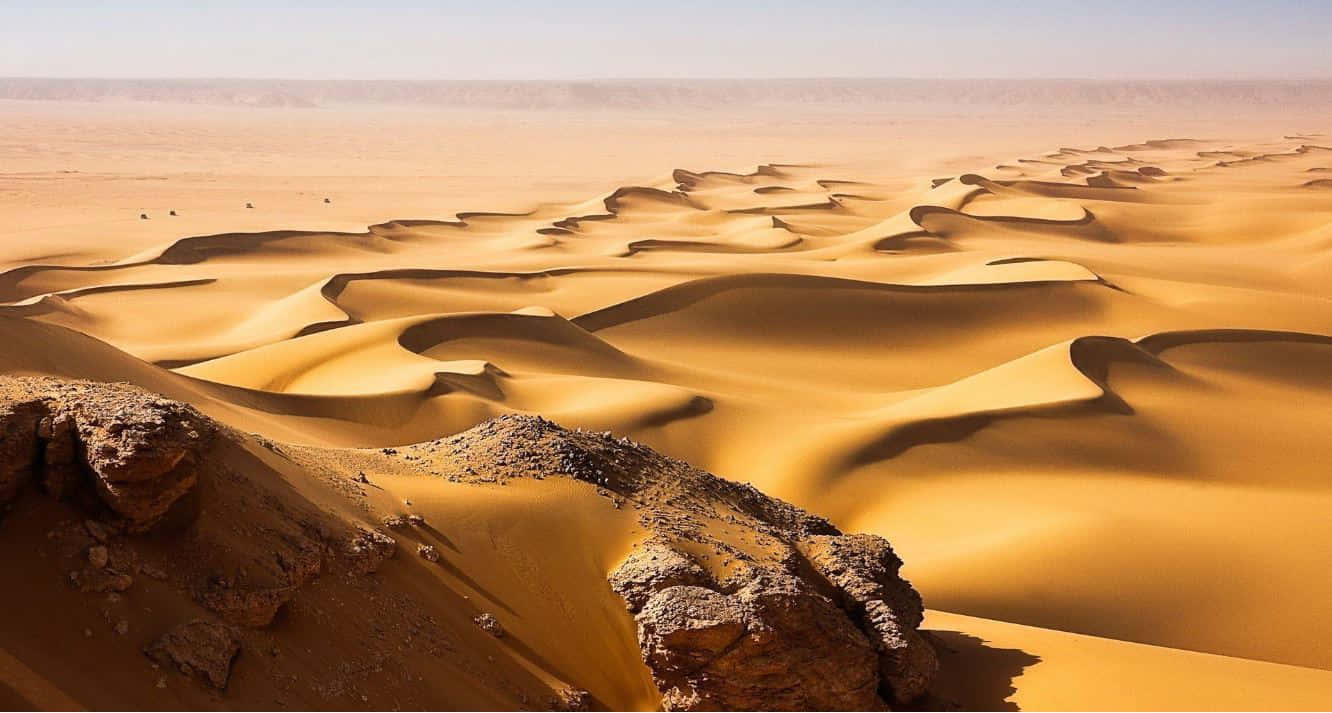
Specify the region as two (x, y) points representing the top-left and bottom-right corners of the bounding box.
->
(610, 534), (938, 710)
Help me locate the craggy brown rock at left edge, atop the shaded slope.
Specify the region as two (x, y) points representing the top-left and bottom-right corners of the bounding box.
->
(0, 377), (216, 532)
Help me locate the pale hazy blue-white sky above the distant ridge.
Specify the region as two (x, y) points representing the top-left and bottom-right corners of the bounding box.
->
(0, 0), (1332, 79)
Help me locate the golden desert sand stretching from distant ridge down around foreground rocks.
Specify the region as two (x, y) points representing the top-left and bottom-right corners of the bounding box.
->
(0, 86), (1332, 710)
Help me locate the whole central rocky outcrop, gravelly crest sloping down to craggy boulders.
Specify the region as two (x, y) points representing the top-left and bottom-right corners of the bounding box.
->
(415, 416), (936, 710)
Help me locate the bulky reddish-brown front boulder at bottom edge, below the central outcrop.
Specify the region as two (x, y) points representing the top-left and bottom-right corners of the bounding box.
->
(637, 576), (883, 710)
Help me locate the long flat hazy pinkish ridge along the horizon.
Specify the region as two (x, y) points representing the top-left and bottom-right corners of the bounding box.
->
(0, 77), (1332, 109)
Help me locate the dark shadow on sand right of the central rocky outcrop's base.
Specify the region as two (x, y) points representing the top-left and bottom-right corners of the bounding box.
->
(916, 629), (1040, 710)
